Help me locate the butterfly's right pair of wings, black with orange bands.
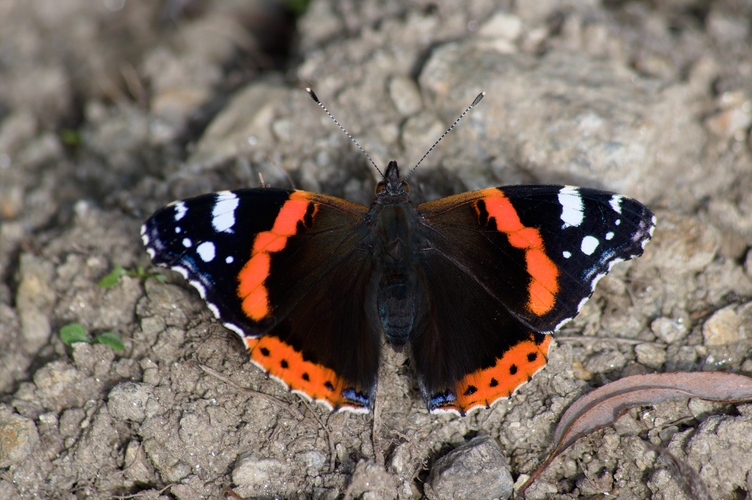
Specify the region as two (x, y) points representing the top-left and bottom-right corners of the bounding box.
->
(411, 186), (655, 413)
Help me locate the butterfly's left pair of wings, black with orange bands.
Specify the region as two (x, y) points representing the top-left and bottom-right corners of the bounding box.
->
(142, 189), (380, 410)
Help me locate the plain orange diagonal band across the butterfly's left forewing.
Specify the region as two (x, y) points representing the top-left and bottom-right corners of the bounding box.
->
(237, 191), (316, 321)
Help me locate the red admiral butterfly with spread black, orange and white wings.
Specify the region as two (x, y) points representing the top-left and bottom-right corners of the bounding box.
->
(141, 90), (655, 415)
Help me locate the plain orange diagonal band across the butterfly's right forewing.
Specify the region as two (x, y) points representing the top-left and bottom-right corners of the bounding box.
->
(476, 188), (559, 316)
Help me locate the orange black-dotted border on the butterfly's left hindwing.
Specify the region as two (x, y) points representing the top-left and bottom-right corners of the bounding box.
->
(245, 335), (362, 409)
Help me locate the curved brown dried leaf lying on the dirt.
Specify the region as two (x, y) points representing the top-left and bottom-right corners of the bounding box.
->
(518, 372), (752, 495)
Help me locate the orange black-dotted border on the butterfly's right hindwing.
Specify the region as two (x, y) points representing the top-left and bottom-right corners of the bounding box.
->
(444, 335), (551, 413)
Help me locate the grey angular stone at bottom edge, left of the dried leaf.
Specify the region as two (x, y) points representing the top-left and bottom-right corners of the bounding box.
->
(425, 435), (514, 500)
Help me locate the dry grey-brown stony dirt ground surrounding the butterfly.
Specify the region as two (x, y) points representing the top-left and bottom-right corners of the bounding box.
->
(0, 0), (752, 499)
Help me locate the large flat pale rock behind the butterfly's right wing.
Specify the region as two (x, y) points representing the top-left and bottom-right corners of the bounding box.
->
(419, 40), (703, 201)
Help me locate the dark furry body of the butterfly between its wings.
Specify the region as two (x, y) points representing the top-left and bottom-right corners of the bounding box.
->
(369, 162), (421, 347)
